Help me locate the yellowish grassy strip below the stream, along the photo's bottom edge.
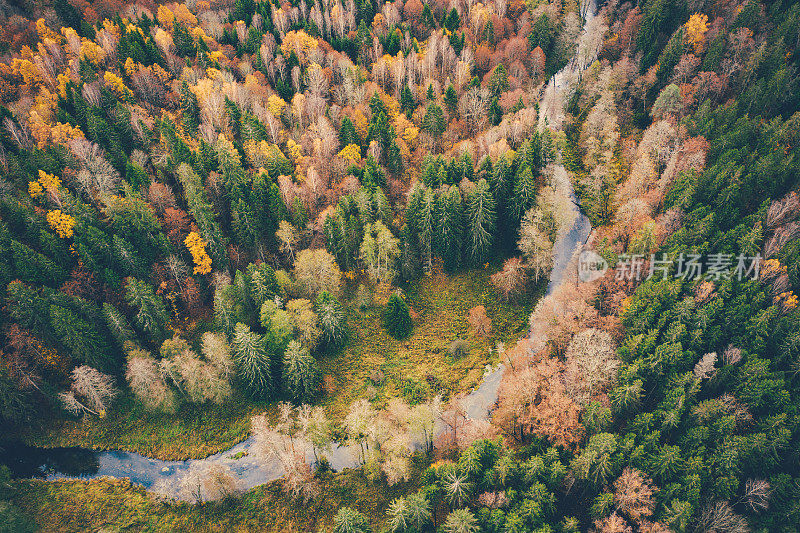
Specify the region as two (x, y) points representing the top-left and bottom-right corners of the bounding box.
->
(12, 462), (416, 533)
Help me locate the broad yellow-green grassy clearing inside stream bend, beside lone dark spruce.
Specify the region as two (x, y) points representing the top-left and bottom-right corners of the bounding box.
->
(320, 270), (538, 418)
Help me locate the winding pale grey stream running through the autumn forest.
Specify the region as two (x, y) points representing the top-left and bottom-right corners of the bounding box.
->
(1, 0), (600, 498)
